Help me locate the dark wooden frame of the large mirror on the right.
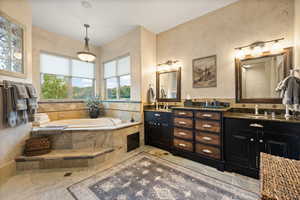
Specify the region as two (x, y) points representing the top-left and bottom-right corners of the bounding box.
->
(235, 47), (293, 104)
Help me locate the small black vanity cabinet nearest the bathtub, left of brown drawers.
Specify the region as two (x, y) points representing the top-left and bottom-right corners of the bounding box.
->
(144, 111), (172, 151)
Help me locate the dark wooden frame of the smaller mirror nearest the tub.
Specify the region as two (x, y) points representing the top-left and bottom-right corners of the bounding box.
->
(156, 67), (181, 102)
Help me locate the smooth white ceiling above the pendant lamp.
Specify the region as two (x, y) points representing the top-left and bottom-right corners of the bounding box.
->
(30, 0), (238, 45)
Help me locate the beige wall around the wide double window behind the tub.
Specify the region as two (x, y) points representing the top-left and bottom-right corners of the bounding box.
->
(32, 26), (101, 97)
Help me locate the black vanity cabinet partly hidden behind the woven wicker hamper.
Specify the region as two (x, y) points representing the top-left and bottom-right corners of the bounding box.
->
(224, 118), (300, 178)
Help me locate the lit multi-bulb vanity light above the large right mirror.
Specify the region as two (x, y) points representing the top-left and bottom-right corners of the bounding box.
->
(235, 38), (284, 59)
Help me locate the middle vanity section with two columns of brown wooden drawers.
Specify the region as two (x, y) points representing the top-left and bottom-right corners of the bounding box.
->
(172, 109), (224, 170)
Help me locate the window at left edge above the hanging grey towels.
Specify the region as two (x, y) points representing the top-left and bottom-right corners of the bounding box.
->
(0, 13), (24, 75)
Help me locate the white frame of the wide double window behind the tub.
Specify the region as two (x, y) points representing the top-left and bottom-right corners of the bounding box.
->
(39, 51), (97, 102)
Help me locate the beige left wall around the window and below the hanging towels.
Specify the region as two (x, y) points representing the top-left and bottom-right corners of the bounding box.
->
(0, 0), (32, 184)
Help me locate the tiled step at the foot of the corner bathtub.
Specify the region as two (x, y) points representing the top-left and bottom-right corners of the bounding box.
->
(16, 148), (114, 171)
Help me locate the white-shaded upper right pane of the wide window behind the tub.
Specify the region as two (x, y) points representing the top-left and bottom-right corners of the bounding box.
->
(72, 60), (95, 78)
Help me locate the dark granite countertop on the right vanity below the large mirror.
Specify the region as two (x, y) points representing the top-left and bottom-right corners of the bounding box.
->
(224, 112), (300, 123)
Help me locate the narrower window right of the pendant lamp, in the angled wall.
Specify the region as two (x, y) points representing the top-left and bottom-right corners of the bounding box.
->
(104, 56), (131, 100)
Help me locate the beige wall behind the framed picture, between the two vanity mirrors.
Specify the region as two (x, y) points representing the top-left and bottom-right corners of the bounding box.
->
(157, 0), (294, 99)
